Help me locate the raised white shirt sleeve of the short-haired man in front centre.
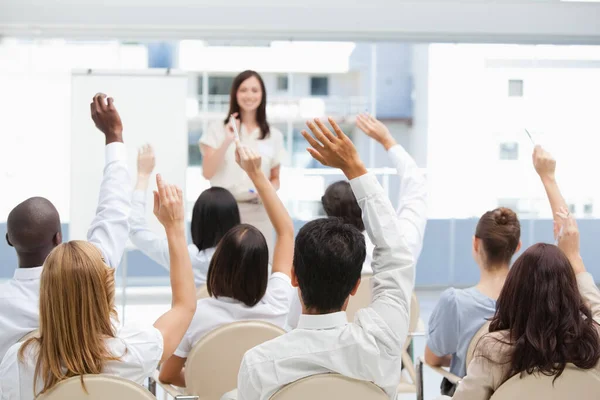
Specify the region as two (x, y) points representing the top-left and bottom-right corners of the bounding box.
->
(350, 174), (415, 354)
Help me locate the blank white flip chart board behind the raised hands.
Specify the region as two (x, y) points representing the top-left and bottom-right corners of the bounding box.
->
(69, 70), (188, 240)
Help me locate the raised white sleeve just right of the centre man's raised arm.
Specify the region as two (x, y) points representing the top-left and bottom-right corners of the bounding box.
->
(388, 145), (427, 260)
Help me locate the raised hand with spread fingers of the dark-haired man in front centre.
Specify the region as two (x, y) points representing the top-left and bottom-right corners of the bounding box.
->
(302, 118), (367, 179)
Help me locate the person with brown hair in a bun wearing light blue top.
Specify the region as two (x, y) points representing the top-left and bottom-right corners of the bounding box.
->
(425, 208), (521, 395)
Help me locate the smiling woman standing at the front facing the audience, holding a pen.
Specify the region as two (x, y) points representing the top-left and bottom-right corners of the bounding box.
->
(200, 71), (284, 259)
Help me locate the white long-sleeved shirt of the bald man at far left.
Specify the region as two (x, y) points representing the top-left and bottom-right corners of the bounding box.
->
(0, 143), (131, 360)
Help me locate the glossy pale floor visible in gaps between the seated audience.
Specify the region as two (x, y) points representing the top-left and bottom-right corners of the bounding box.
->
(117, 287), (441, 400)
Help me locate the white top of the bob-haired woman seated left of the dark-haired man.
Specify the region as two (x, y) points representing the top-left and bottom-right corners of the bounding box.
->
(174, 272), (294, 358)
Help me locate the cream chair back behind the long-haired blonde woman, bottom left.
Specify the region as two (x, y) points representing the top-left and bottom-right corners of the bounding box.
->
(38, 375), (156, 400)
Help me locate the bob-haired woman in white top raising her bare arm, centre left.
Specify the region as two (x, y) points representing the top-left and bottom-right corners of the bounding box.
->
(159, 143), (295, 387)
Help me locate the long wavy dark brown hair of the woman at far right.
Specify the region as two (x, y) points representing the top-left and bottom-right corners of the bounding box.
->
(490, 243), (600, 379)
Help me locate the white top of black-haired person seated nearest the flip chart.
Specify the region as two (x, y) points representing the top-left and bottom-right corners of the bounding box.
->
(129, 190), (216, 287)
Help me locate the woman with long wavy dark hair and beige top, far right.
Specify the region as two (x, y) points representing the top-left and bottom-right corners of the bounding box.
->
(453, 147), (600, 400)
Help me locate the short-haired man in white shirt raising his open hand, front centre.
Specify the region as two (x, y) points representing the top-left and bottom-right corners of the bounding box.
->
(237, 119), (425, 400)
